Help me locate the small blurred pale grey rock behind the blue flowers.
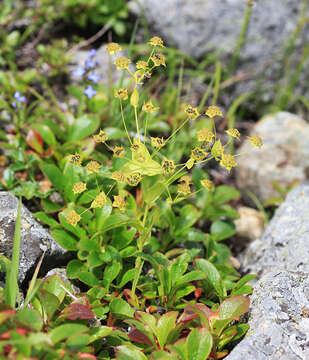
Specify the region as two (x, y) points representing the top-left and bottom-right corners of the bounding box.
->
(70, 45), (134, 86)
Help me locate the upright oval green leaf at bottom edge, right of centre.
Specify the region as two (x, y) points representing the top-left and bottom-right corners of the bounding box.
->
(187, 328), (213, 360)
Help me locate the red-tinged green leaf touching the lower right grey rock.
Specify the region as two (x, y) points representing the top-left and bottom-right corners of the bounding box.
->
(218, 296), (250, 320)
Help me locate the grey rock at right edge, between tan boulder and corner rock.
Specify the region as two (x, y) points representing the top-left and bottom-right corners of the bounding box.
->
(240, 185), (309, 275)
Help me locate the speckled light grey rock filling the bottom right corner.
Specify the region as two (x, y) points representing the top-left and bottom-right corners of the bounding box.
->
(225, 271), (309, 360)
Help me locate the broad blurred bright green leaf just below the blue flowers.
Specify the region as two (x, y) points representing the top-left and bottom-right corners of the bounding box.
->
(68, 115), (100, 141)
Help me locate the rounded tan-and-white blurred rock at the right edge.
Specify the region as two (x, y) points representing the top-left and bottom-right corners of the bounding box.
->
(235, 112), (309, 201)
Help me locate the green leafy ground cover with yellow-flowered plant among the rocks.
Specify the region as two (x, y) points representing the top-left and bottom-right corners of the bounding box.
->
(0, 0), (304, 360)
